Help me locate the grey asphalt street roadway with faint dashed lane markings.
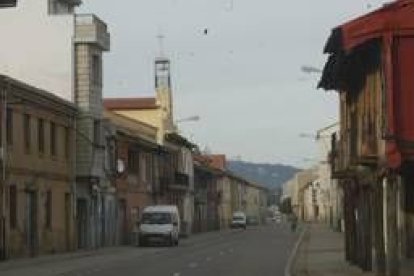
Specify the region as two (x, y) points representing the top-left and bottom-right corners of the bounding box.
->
(0, 224), (297, 276)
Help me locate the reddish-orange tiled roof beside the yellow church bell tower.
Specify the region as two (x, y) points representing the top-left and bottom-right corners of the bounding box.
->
(103, 98), (158, 110)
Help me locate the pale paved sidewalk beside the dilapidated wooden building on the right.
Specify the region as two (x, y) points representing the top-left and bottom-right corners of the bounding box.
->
(293, 224), (414, 276)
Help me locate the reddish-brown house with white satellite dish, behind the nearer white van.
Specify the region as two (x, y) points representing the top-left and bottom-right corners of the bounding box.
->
(104, 111), (161, 244)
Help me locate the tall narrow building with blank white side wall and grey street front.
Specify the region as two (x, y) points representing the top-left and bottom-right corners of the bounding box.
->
(0, 0), (115, 248)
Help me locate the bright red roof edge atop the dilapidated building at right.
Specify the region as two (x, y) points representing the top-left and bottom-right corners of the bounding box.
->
(339, 0), (414, 52)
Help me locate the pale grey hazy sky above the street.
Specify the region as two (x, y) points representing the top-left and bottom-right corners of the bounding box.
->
(79, 0), (385, 167)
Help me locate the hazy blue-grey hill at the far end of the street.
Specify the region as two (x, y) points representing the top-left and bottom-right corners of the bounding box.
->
(227, 160), (300, 189)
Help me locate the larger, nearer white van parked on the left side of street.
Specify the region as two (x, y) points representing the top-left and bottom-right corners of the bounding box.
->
(139, 205), (180, 246)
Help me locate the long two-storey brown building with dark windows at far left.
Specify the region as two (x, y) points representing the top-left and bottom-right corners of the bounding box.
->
(0, 76), (77, 259)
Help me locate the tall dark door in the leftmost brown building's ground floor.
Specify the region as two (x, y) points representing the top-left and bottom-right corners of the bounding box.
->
(26, 191), (38, 257)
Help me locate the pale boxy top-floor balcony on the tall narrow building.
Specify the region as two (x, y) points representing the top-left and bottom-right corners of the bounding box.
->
(75, 14), (111, 51)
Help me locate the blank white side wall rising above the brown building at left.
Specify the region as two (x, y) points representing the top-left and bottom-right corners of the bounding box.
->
(0, 0), (74, 101)
